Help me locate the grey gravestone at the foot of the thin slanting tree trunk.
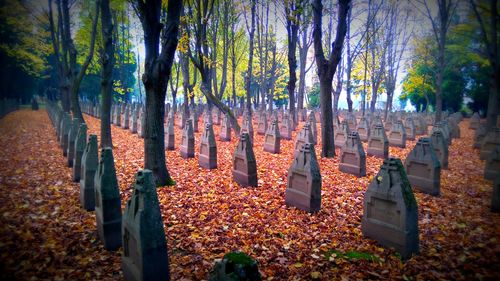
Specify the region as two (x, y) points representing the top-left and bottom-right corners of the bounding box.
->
(233, 133), (257, 187)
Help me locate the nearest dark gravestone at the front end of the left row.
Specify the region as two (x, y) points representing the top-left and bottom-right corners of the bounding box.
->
(122, 170), (170, 281)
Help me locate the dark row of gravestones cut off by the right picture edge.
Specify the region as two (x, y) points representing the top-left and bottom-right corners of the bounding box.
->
(469, 112), (500, 213)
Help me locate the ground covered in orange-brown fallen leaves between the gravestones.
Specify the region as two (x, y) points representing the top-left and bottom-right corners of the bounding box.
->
(0, 109), (500, 280)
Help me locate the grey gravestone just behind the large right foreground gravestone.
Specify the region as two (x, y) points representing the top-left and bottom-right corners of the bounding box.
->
(405, 137), (441, 196)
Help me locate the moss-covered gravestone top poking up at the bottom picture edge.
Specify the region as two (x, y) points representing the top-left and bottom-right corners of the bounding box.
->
(208, 252), (262, 281)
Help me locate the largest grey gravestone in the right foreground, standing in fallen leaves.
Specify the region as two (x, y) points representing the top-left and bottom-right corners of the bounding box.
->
(361, 158), (419, 260)
